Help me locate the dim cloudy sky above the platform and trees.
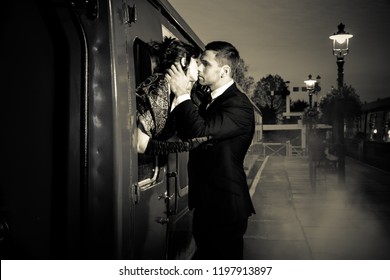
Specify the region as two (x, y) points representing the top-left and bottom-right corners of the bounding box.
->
(169, 0), (390, 102)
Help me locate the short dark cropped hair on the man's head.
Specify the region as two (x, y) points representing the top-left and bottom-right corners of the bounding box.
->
(205, 41), (240, 73)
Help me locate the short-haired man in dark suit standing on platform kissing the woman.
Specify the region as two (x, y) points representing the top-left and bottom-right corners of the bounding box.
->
(166, 41), (255, 259)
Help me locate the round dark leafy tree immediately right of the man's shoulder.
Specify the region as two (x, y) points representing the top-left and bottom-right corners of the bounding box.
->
(252, 75), (290, 124)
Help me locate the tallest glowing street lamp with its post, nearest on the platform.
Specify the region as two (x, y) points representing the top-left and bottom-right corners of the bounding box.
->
(329, 23), (353, 183)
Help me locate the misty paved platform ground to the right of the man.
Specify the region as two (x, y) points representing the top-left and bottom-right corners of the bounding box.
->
(244, 156), (390, 260)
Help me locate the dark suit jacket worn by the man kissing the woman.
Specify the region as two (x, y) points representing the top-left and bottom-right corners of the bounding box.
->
(173, 84), (255, 224)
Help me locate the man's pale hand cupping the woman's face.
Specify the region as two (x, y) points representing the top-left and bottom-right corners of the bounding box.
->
(165, 63), (191, 97)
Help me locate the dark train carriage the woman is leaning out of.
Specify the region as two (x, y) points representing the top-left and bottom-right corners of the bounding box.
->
(0, 0), (204, 259)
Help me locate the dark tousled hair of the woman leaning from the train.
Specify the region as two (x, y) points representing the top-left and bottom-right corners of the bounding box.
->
(150, 37), (201, 73)
